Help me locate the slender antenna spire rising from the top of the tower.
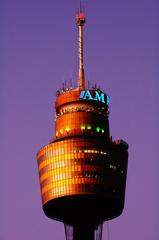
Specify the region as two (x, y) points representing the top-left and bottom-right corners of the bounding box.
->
(76, 1), (86, 89)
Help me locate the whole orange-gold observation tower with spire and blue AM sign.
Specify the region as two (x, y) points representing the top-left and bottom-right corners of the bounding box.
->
(37, 5), (128, 240)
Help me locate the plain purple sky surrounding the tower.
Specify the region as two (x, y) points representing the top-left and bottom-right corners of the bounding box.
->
(0, 0), (159, 240)
